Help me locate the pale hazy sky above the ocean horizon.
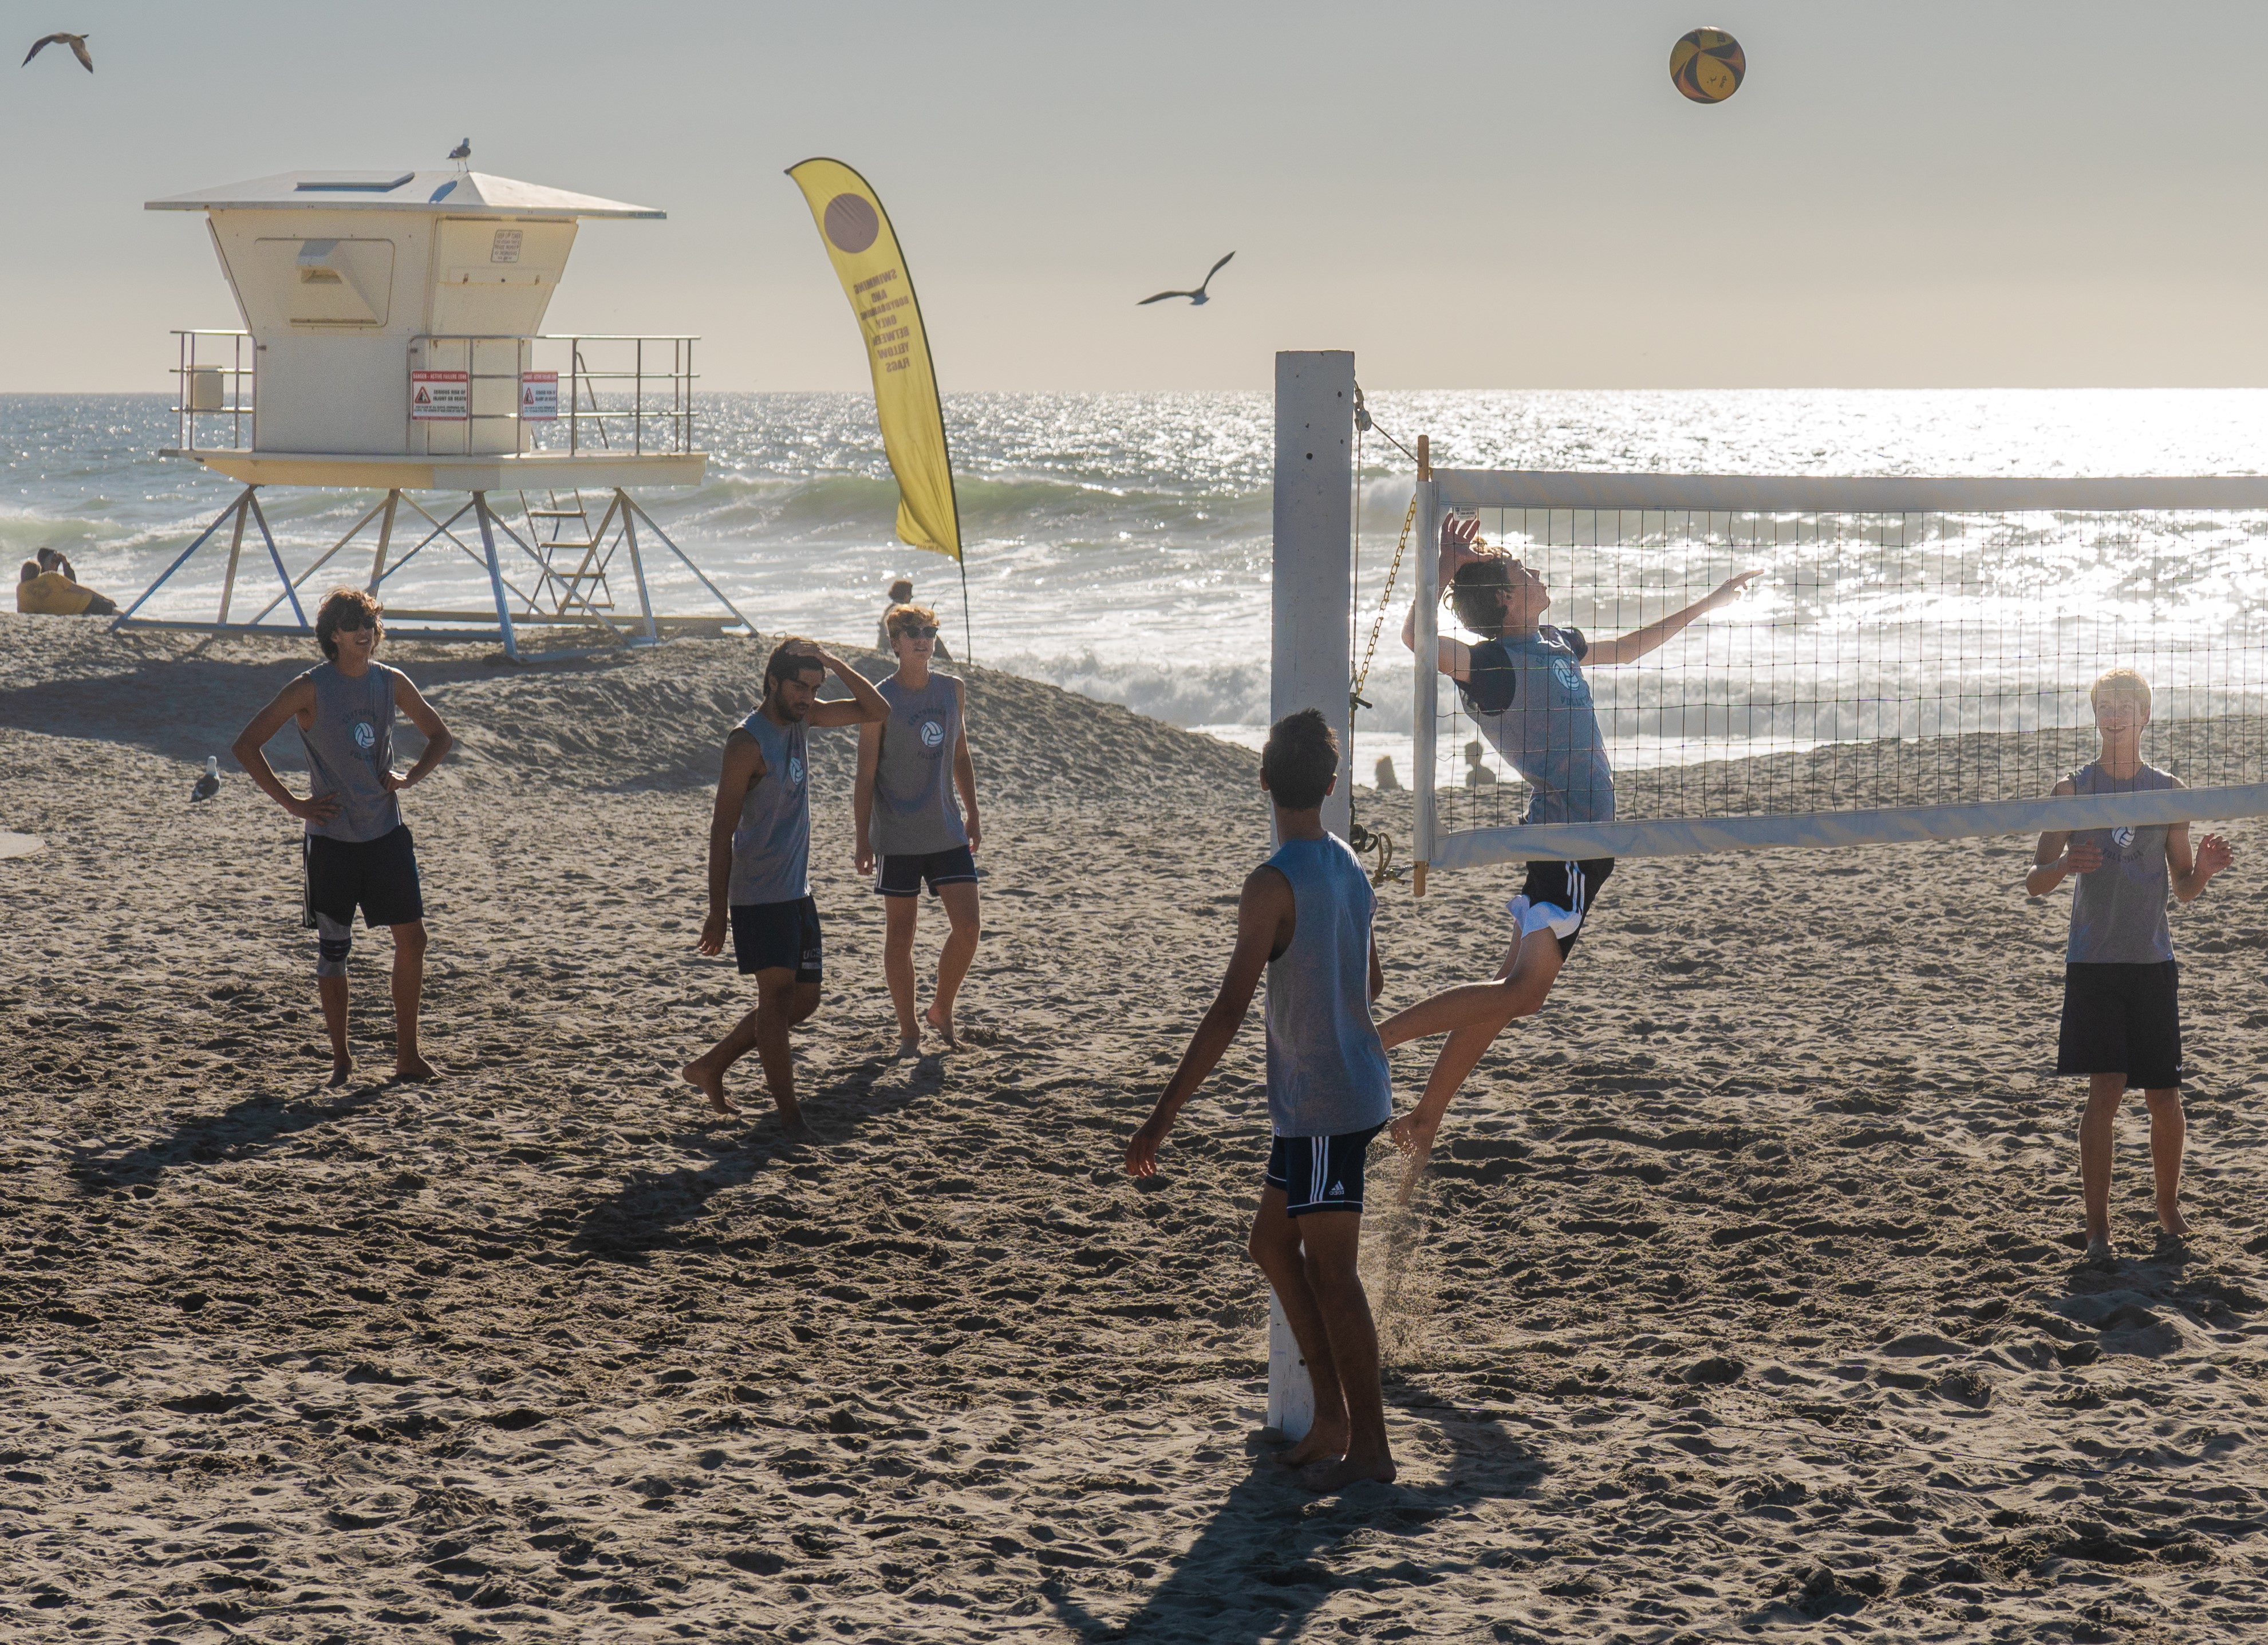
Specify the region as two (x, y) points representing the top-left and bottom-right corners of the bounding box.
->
(0, 0), (2268, 395)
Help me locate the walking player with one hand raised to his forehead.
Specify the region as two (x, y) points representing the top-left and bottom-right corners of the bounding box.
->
(680, 636), (889, 1137)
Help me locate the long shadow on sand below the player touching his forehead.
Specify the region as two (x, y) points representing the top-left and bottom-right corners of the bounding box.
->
(567, 1055), (944, 1264)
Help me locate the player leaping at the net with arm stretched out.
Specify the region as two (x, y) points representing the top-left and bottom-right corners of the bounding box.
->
(1379, 515), (1760, 1187)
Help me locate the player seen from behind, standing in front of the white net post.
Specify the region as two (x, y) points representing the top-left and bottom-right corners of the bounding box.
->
(1127, 708), (1395, 1491)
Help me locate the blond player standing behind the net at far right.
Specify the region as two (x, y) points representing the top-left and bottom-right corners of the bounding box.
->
(2023, 669), (2234, 1259)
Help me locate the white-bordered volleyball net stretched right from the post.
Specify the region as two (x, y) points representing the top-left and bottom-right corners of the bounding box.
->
(1411, 467), (2268, 867)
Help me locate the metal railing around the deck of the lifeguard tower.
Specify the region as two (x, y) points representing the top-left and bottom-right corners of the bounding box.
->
(172, 332), (701, 456)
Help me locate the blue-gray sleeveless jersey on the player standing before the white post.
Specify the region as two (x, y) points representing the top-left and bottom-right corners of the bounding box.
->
(1268, 835), (1395, 1137)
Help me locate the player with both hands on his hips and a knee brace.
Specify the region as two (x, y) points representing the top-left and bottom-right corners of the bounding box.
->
(231, 587), (456, 1084)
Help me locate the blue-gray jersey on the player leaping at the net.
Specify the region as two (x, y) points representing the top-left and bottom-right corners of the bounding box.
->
(1458, 629), (1615, 823)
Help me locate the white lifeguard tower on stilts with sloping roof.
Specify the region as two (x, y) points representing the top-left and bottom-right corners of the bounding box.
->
(118, 168), (755, 660)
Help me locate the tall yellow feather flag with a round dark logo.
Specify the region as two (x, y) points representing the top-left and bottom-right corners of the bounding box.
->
(787, 159), (961, 561)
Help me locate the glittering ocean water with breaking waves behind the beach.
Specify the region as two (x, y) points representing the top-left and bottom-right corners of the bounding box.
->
(0, 390), (2268, 776)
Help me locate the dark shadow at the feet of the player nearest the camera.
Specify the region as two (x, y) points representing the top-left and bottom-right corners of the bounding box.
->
(1041, 1384), (1544, 1645)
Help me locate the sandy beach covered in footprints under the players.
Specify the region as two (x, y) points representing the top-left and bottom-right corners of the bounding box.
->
(0, 615), (2268, 1645)
